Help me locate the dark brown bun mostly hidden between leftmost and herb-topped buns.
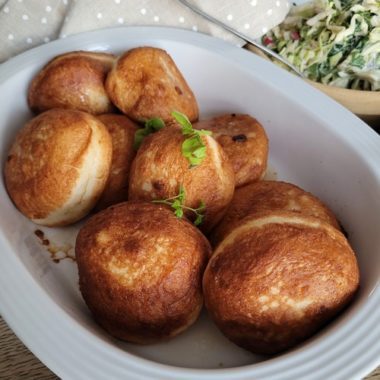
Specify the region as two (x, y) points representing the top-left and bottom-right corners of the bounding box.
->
(96, 114), (138, 210)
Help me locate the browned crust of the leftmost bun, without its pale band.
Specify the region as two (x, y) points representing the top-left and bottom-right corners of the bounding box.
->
(4, 109), (112, 224)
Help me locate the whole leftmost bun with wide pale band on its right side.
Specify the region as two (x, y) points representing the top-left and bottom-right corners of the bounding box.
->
(5, 109), (112, 226)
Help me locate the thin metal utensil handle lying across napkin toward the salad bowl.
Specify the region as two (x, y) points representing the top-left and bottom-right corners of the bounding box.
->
(179, 0), (305, 78)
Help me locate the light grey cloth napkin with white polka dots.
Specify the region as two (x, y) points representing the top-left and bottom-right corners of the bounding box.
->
(0, 0), (289, 62)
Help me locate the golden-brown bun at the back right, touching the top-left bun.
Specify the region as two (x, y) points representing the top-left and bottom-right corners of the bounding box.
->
(106, 47), (198, 121)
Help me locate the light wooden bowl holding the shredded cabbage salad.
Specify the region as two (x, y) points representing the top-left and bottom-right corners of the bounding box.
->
(246, 44), (380, 131)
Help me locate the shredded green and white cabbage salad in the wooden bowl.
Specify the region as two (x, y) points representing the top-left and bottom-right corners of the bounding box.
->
(262, 0), (380, 91)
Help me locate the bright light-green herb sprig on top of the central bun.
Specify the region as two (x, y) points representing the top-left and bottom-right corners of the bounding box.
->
(172, 111), (212, 167)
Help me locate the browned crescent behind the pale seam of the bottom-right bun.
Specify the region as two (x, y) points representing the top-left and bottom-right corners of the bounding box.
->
(211, 181), (340, 245)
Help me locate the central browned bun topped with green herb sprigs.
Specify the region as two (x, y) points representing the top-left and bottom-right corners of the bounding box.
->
(129, 126), (235, 231)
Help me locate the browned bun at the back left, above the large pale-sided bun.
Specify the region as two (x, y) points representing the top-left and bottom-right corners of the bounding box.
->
(28, 51), (116, 115)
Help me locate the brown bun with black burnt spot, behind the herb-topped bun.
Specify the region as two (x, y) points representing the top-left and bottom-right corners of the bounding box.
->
(194, 113), (269, 187)
